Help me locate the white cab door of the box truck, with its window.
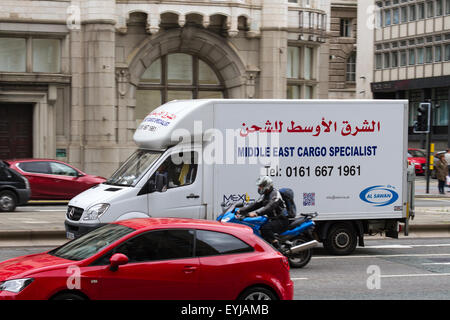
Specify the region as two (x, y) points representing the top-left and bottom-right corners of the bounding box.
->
(147, 151), (205, 218)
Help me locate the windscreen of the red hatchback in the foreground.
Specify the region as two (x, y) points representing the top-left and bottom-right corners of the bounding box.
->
(48, 224), (135, 261)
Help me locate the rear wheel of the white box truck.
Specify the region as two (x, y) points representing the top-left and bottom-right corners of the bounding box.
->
(323, 223), (358, 256)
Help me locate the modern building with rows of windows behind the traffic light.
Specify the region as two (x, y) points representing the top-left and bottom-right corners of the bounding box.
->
(357, 0), (450, 150)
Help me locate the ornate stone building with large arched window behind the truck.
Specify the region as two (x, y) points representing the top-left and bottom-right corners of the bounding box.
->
(0, 0), (330, 176)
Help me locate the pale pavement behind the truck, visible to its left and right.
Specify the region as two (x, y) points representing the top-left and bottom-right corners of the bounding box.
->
(0, 177), (450, 247)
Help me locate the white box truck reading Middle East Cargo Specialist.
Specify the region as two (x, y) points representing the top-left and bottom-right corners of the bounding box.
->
(65, 99), (410, 254)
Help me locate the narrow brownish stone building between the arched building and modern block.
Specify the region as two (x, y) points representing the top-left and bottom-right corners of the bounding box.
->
(328, 0), (357, 99)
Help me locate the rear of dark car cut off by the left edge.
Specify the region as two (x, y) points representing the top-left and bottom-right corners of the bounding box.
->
(0, 161), (31, 211)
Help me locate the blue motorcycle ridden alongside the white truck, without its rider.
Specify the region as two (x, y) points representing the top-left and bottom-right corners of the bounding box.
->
(217, 203), (319, 268)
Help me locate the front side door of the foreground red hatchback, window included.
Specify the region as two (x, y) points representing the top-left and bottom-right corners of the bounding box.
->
(95, 229), (200, 300)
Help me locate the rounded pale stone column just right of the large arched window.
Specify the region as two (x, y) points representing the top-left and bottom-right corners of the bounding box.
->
(259, 0), (288, 99)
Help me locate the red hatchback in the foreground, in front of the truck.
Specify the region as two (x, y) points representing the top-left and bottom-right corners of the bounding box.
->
(0, 218), (293, 300)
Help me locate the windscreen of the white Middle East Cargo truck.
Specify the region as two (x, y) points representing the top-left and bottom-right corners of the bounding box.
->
(105, 149), (162, 187)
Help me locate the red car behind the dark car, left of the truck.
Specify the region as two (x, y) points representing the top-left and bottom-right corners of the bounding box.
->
(5, 159), (106, 200)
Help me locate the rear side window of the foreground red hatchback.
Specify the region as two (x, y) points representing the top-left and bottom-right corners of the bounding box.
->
(195, 230), (254, 257)
